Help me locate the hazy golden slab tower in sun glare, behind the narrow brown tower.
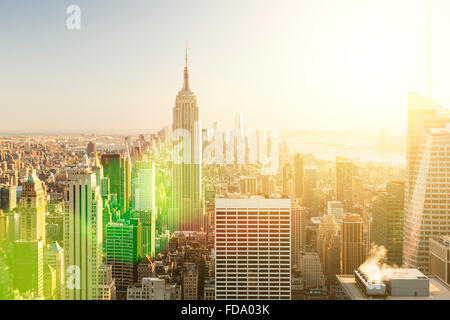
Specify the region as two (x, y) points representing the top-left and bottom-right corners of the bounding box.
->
(336, 157), (353, 212)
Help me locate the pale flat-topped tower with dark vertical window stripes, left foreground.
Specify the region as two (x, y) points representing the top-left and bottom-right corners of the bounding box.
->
(64, 170), (102, 300)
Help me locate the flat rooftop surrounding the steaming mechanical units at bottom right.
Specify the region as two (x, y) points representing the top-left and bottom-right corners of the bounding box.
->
(336, 275), (450, 300)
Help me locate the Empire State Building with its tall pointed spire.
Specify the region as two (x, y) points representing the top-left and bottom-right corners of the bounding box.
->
(168, 49), (203, 232)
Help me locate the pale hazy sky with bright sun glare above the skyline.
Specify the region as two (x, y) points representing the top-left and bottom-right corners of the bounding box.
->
(0, 0), (450, 132)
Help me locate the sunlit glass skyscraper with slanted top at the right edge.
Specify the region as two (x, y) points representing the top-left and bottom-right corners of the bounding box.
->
(403, 92), (450, 273)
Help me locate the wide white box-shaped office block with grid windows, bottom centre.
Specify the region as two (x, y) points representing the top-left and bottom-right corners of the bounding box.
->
(215, 198), (291, 300)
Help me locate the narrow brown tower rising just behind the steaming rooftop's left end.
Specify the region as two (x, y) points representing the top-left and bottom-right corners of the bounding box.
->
(341, 214), (365, 274)
